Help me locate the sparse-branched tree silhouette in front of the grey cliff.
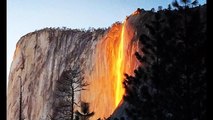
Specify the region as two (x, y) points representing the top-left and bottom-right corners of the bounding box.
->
(53, 67), (89, 120)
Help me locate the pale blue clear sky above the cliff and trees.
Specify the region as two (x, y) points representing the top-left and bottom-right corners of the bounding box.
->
(7, 0), (206, 86)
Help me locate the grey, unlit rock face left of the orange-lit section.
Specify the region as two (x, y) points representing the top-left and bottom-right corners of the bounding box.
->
(7, 29), (105, 120)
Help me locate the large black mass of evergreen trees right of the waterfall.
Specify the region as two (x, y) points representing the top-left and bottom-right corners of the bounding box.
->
(123, 5), (206, 120)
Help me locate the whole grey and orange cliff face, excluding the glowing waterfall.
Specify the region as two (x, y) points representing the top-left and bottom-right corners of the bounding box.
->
(7, 5), (206, 120)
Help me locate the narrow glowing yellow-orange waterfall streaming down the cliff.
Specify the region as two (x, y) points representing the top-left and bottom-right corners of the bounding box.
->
(115, 21), (125, 106)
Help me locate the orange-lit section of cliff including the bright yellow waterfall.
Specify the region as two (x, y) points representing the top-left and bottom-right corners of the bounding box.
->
(81, 21), (138, 120)
